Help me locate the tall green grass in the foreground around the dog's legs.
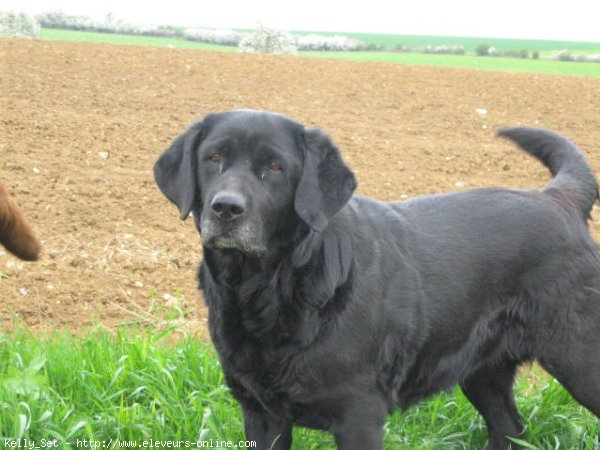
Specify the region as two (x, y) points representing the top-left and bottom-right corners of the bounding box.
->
(0, 329), (600, 450)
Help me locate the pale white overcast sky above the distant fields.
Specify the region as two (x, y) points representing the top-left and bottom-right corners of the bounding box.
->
(0, 0), (600, 42)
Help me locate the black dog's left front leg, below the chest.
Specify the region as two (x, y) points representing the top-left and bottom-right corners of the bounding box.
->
(242, 405), (292, 450)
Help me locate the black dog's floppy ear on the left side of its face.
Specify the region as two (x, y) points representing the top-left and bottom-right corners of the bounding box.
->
(154, 122), (204, 220)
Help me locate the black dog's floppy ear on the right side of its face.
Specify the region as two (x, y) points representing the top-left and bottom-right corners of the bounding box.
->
(294, 129), (356, 231)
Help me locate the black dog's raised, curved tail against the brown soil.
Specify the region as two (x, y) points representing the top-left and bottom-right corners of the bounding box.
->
(498, 127), (599, 220)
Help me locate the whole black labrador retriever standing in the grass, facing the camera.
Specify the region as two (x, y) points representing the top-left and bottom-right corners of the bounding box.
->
(154, 110), (600, 450)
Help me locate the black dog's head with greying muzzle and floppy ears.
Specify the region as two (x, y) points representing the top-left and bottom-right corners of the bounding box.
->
(154, 110), (356, 255)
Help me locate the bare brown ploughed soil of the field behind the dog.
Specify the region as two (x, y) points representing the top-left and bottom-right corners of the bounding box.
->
(0, 39), (600, 332)
